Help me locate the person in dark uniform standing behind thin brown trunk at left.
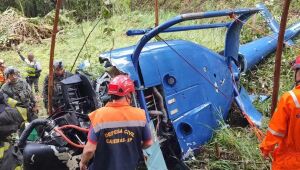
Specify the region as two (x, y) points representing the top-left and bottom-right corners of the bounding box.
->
(43, 61), (73, 111)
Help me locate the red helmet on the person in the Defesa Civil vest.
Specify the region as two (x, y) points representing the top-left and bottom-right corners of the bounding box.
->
(108, 75), (135, 96)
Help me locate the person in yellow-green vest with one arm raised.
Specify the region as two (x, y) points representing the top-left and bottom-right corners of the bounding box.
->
(17, 50), (42, 93)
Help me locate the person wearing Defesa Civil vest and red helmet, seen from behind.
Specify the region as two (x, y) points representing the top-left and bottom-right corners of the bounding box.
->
(80, 75), (152, 170)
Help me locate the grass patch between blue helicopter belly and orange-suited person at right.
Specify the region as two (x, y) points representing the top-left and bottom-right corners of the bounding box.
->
(187, 107), (270, 170)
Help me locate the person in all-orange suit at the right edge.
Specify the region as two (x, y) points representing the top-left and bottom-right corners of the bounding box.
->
(260, 56), (300, 170)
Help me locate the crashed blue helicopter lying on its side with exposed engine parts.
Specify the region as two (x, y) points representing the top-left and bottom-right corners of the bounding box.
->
(18, 4), (300, 169)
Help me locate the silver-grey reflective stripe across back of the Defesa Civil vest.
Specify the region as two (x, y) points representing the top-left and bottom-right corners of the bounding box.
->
(94, 120), (146, 133)
